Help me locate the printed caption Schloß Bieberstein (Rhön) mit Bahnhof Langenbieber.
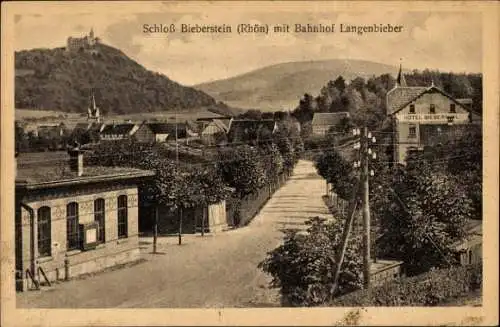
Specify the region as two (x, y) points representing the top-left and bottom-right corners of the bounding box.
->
(142, 23), (403, 35)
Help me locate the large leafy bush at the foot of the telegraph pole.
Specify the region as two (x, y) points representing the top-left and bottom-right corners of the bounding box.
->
(259, 217), (362, 306)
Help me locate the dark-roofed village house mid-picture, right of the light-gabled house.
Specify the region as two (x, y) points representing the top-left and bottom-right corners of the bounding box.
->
(227, 119), (278, 143)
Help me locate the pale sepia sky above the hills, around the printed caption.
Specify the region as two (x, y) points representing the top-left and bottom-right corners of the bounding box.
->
(14, 2), (482, 85)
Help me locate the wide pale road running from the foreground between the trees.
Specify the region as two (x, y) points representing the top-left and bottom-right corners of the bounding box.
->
(17, 161), (329, 308)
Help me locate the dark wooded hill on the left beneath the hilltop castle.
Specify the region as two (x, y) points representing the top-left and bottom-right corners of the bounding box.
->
(15, 43), (232, 114)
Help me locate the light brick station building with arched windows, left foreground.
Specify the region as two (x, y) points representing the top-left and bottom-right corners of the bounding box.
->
(15, 149), (154, 291)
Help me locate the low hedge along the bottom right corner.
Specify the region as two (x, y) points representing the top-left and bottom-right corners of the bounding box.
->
(330, 265), (482, 306)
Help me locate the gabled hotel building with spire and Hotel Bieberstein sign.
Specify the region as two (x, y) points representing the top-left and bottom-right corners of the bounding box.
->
(387, 69), (481, 164)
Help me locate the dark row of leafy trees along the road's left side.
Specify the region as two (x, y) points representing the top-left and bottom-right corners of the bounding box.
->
(86, 120), (302, 228)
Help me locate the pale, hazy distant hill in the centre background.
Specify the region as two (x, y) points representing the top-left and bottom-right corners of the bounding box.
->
(194, 59), (398, 111)
